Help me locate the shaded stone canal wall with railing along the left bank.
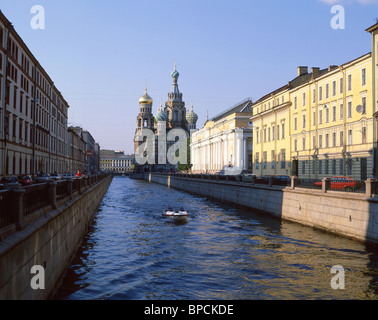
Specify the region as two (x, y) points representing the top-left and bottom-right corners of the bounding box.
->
(0, 175), (112, 300)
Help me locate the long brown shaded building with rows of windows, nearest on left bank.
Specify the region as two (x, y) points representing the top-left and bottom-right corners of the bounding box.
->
(0, 11), (69, 176)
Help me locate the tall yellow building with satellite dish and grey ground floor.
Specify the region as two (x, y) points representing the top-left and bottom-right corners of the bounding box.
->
(290, 53), (373, 180)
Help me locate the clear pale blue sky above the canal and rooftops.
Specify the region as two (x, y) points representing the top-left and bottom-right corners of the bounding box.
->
(0, 0), (378, 153)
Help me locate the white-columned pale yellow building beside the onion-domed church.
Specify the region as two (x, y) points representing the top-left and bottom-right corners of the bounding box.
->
(190, 99), (252, 174)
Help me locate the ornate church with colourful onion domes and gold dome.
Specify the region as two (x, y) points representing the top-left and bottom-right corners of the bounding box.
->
(134, 66), (198, 171)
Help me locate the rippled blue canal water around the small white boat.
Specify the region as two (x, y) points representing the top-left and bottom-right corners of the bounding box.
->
(53, 177), (378, 300)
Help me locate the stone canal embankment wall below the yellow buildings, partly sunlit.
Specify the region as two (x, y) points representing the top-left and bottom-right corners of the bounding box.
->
(144, 173), (378, 244)
